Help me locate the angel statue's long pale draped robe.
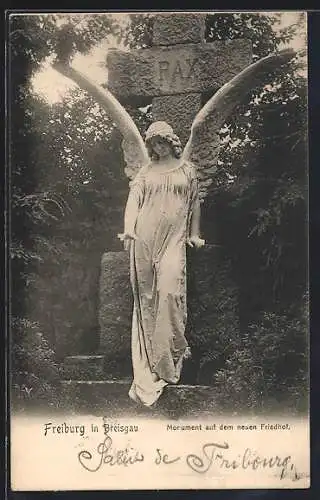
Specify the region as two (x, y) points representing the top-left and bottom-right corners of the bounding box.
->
(125, 162), (198, 406)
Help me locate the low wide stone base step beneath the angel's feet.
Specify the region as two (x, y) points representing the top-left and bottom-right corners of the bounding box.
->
(62, 379), (217, 419)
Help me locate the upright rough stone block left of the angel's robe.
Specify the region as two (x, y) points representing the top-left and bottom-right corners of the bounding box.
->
(99, 252), (133, 376)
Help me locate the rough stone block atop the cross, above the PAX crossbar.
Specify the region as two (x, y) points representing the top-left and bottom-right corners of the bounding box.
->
(153, 13), (206, 45)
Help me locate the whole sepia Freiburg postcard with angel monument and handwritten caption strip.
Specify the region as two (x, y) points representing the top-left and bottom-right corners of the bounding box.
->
(6, 10), (310, 491)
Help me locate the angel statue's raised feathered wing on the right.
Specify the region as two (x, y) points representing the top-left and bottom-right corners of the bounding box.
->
(183, 49), (296, 201)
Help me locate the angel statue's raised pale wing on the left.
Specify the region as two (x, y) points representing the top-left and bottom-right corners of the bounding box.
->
(53, 61), (149, 179)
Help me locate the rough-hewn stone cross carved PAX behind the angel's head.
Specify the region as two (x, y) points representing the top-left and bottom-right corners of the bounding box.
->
(107, 13), (252, 144)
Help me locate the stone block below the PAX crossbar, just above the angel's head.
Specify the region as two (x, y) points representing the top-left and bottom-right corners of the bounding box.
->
(152, 93), (201, 146)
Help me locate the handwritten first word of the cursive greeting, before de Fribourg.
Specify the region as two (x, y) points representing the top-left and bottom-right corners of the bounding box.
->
(78, 435), (144, 472)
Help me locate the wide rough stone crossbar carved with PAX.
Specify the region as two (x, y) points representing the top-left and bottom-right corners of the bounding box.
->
(107, 39), (252, 98)
